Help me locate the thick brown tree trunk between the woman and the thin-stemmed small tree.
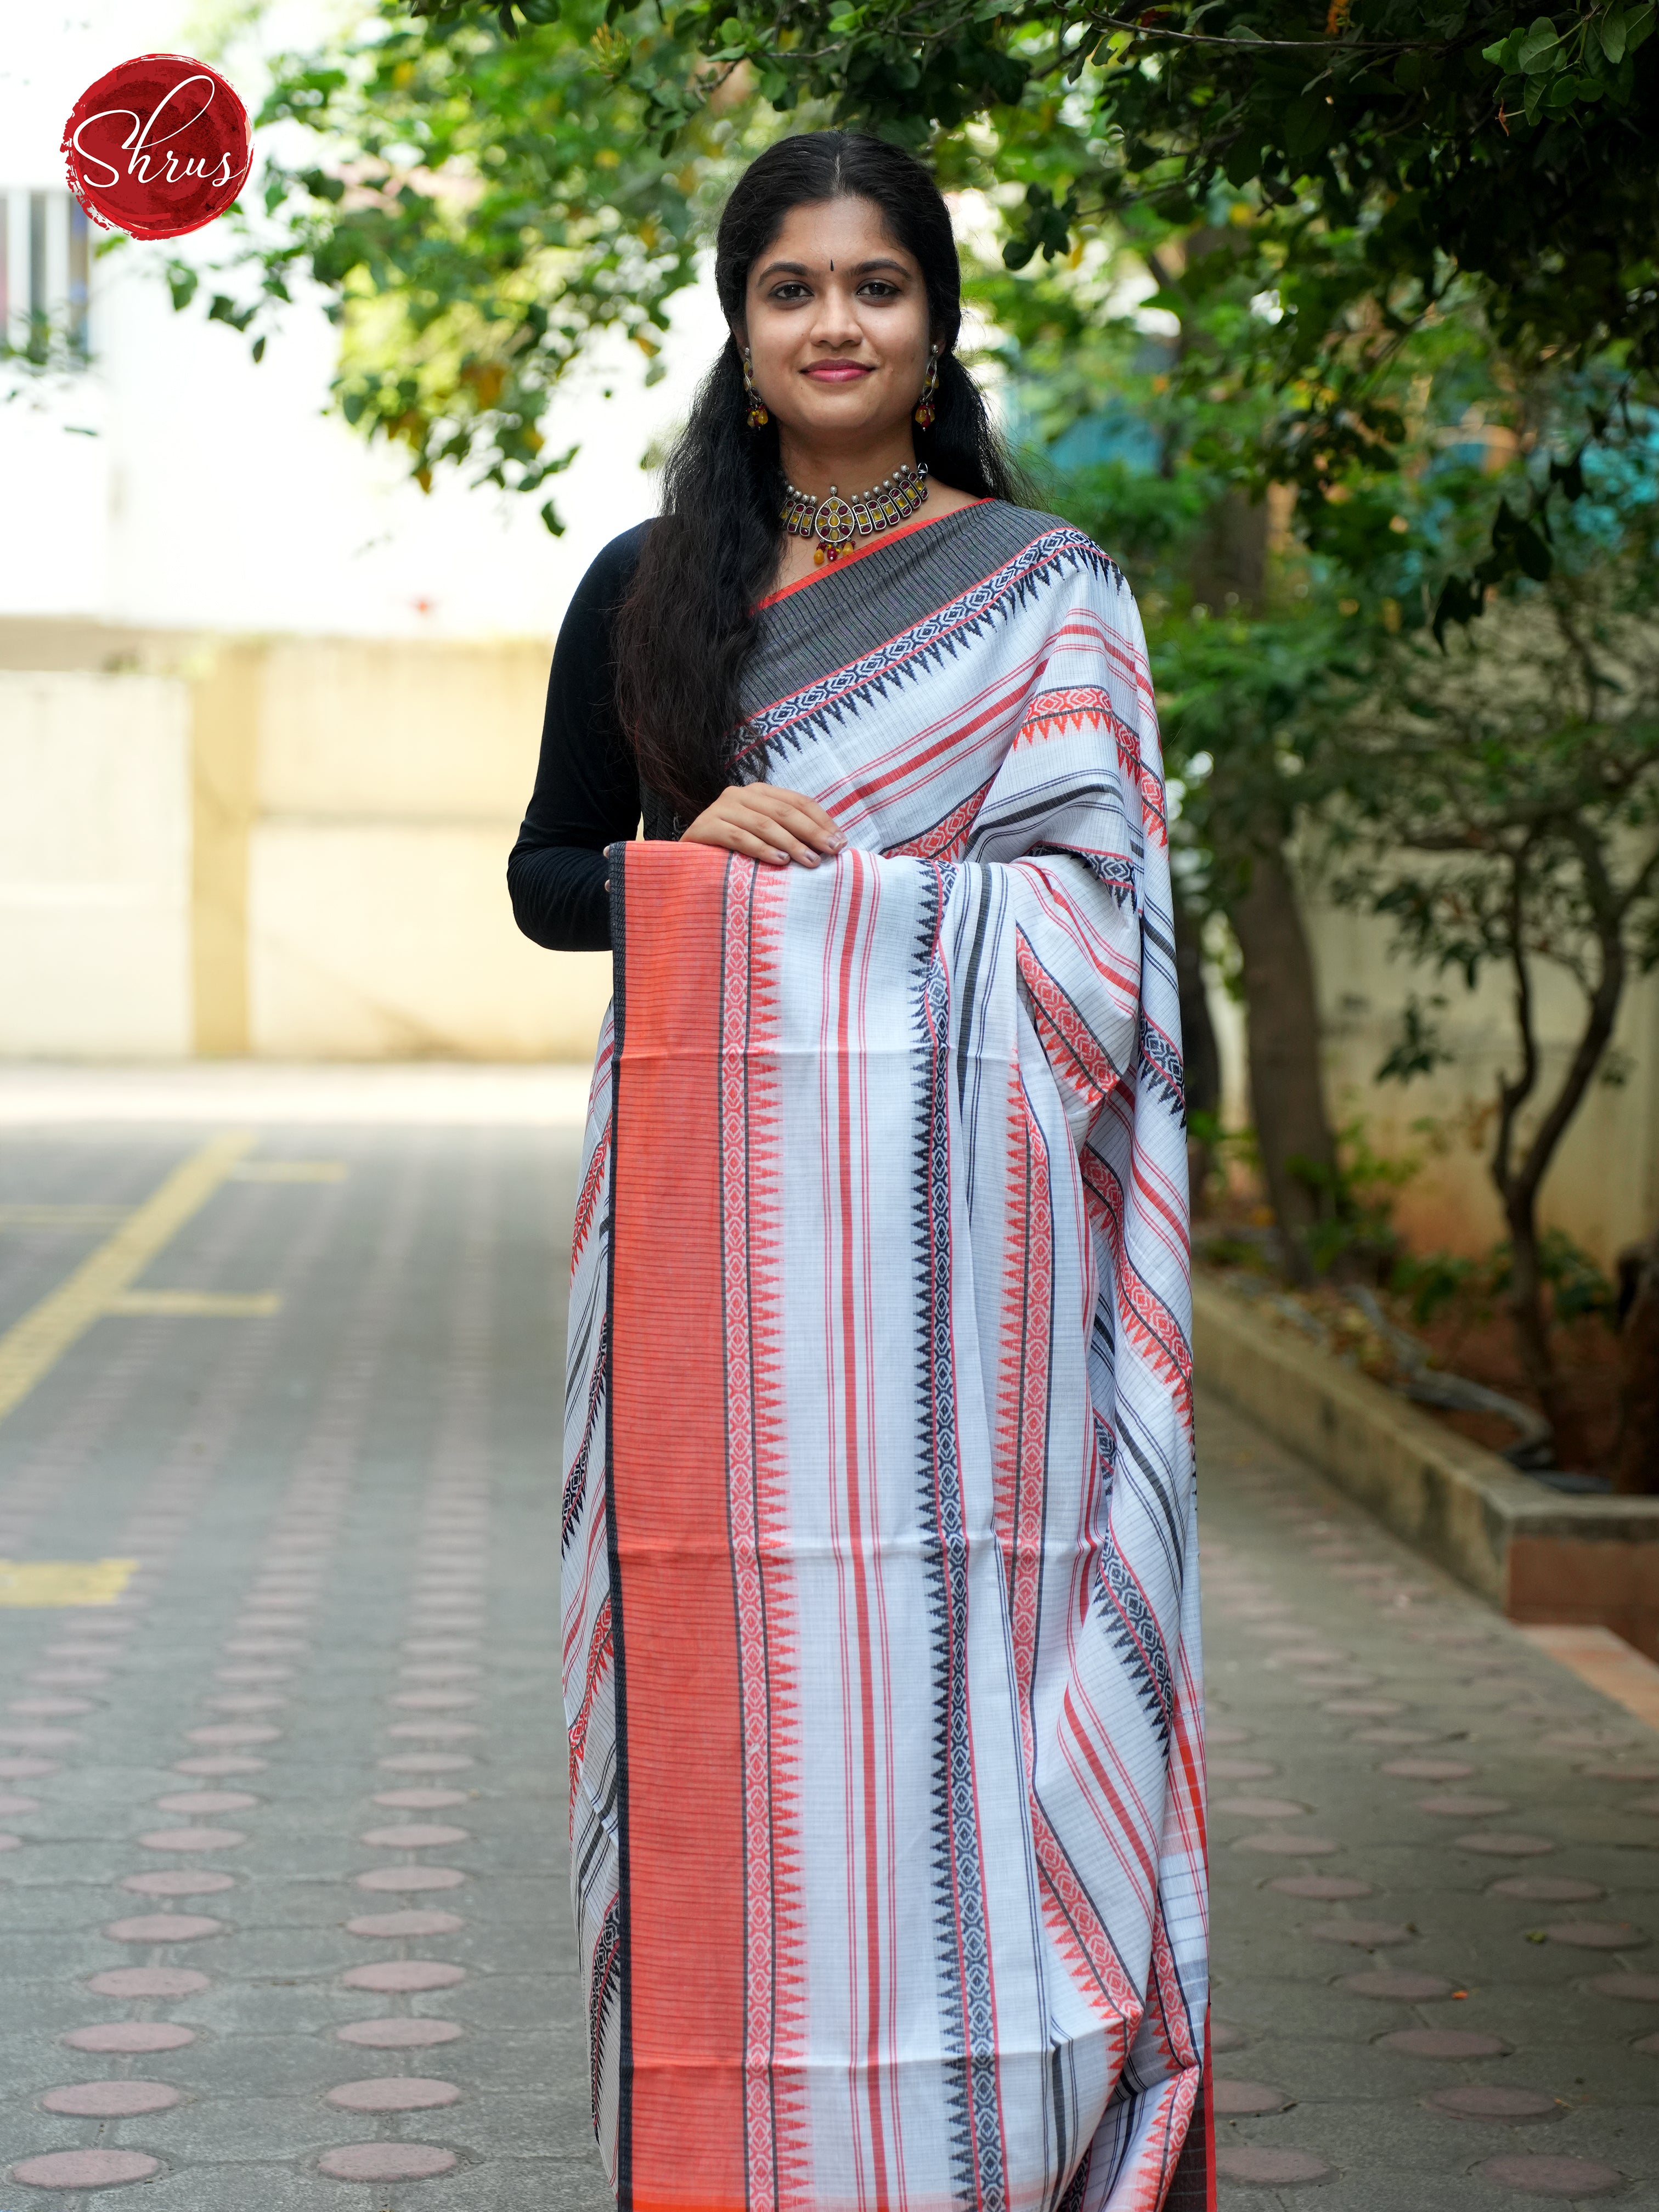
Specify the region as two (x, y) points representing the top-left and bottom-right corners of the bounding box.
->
(1230, 847), (1338, 1283)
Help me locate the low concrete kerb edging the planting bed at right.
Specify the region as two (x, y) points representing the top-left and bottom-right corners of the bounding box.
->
(1192, 1276), (1659, 1659)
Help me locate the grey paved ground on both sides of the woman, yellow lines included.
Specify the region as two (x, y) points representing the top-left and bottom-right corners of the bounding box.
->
(0, 1077), (1659, 2212)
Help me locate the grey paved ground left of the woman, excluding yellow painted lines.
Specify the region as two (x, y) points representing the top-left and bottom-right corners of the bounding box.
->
(0, 1128), (611, 2212)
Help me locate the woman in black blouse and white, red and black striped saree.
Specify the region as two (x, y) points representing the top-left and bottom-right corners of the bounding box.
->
(509, 133), (1210, 2212)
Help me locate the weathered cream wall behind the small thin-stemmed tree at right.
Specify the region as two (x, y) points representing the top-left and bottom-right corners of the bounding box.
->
(1310, 907), (1659, 1267)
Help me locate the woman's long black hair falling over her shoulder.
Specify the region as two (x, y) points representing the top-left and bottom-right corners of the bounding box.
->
(615, 131), (1018, 821)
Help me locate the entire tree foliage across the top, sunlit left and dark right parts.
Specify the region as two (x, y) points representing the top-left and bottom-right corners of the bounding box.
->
(208, 0), (1659, 614)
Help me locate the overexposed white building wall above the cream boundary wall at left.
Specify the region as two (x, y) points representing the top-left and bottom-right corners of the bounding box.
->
(0, 0), (723, 637)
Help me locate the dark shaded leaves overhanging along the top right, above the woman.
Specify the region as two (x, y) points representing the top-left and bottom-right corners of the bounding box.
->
(429, 0), (1659, 628)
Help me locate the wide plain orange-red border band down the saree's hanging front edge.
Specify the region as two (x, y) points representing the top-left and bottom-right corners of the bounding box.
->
(606, 843), (750, 2212)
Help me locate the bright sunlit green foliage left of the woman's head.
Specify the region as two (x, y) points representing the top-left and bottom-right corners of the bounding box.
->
(170, 0), (761, 531)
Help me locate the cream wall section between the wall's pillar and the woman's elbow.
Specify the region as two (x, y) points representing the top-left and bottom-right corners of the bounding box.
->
(248, 639), (611, 1059)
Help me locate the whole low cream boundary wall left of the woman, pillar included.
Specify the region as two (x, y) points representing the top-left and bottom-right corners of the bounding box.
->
(0, 622), (611, 1059)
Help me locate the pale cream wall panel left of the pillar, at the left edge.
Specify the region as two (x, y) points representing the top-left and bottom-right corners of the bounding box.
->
(0, 670), (190, 1059)
